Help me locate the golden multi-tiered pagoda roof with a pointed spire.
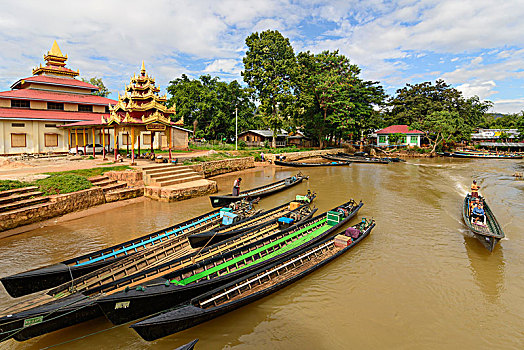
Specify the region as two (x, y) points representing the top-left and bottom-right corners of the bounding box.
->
(107, 62), (183, 125)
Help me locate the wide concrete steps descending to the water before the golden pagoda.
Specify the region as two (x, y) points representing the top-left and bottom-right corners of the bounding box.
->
(141, 164), (204, 187)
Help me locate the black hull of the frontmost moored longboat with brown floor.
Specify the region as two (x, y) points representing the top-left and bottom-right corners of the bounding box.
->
(131, 224), (375, 341)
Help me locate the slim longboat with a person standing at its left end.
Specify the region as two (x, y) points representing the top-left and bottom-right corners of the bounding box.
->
(209, 173), (309, 208)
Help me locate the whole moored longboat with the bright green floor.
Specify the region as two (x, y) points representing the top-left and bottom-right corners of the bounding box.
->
(97, 201), (362, 324)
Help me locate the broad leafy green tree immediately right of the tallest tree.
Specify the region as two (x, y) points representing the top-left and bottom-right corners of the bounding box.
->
(298, 51), (385, 148)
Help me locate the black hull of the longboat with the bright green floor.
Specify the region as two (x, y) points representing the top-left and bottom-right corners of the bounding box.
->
(97, 202), (363, 324)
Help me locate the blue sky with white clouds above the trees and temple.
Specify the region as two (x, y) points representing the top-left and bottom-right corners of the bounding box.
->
(0, 0), (524, 113)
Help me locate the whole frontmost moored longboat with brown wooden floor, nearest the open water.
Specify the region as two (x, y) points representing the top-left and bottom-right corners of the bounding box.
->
(131, 221), (375, 341)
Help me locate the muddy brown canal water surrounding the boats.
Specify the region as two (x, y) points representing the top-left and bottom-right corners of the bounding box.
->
(0, 159), (524, 350)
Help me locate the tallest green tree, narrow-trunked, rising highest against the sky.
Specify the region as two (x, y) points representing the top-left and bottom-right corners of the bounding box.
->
(242, 30), (298, 147)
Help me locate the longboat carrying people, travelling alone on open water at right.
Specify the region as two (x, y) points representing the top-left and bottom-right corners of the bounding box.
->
(462, 193), (505, 252)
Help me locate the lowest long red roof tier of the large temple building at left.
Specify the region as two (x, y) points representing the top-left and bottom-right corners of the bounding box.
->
(0, 108), (109, 122)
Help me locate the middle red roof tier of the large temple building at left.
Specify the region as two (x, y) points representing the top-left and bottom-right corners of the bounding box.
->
(0, 89), (117, 106)
